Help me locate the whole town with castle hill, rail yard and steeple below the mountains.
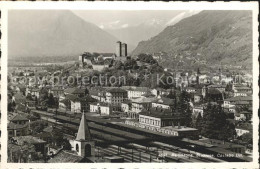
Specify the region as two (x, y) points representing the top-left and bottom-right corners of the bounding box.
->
(7, 41), (253, 163)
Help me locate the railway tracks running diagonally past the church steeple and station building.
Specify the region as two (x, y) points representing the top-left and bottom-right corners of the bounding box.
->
(31, 110), (252, 162)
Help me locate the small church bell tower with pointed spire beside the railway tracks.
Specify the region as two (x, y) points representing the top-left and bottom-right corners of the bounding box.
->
(72, 112), (95, 157)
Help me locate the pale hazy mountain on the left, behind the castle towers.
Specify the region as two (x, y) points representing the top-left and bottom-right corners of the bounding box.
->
(8, 10), (117, 58)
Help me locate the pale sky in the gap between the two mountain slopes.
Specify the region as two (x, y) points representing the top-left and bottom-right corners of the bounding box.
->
(72, 10), (199, 29)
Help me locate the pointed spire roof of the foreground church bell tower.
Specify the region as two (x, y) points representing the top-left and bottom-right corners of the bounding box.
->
(76, 112), (91, 141)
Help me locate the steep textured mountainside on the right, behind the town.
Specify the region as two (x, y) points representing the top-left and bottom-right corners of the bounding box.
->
(132, 11), (252, 69)
